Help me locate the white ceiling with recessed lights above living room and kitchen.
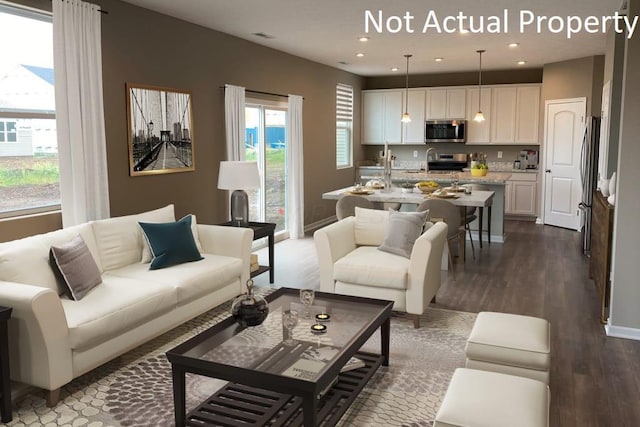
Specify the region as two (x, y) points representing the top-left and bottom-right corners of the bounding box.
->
(120, 0), (624, 76)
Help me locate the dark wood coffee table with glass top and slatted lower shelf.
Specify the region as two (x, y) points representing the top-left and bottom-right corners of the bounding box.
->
(167, 288), (393, 426)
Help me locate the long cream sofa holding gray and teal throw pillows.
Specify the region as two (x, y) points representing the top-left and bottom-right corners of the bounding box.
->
(0, 205), (253, 404)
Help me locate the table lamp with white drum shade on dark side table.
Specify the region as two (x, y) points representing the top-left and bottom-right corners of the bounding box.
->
(218, 161), (260, 227)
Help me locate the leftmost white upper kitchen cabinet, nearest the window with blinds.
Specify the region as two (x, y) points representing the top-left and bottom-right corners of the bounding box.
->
(362, 90), (403, 145)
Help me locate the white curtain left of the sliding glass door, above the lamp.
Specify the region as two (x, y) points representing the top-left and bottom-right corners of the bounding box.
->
(224, 85), (246, 160)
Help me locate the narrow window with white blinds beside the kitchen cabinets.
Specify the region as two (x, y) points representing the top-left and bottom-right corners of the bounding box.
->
(336, 84), (353, 169)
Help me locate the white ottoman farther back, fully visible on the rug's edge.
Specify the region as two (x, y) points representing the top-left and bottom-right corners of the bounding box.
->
(466, 311), (551, 384)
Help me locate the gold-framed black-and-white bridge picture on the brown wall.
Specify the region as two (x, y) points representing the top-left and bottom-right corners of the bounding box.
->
(125, 83), (195, 176)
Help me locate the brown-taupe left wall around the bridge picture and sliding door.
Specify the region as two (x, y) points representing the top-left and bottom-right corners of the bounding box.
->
(0, 0), (364, 241)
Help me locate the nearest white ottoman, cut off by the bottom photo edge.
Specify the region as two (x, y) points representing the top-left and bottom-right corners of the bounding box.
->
(433, 368), (550, 427)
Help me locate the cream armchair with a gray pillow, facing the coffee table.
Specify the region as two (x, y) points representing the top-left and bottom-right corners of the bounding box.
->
(314, 211), (447, 328)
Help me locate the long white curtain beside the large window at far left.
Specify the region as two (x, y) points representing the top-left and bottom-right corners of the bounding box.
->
(53, 0), (109, 227)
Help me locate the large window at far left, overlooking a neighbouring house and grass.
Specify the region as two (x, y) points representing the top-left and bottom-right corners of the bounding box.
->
(0, 3), (60, 217)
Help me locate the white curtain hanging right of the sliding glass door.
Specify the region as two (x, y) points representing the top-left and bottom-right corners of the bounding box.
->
(287, 95), (304, 239)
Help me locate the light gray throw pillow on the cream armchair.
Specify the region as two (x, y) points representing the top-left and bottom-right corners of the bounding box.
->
(378, 209), (429, 258)
